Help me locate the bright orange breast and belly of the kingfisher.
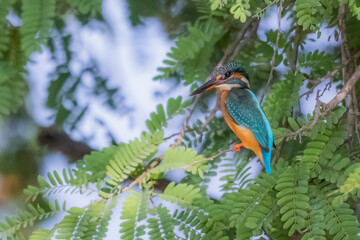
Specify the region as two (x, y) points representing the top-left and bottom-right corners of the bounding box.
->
(220, 91), (263, 163)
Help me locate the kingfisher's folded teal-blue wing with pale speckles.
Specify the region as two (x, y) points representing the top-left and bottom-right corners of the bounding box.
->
(226, 88), (273, 152)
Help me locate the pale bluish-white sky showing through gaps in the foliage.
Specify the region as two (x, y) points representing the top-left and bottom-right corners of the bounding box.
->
(2, 0), (344, 239)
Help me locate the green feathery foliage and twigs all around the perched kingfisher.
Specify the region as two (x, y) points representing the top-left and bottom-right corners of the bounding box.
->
(0, 0), (360, 240)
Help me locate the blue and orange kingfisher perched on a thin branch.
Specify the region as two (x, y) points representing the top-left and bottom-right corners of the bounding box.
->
(191, 62), (274, 174)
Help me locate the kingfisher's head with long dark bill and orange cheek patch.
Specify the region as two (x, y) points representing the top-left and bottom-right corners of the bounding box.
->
(191, 62), (250, 95)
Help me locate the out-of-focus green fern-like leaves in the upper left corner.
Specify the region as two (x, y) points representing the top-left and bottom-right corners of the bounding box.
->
(0, 0), (107, 120)
